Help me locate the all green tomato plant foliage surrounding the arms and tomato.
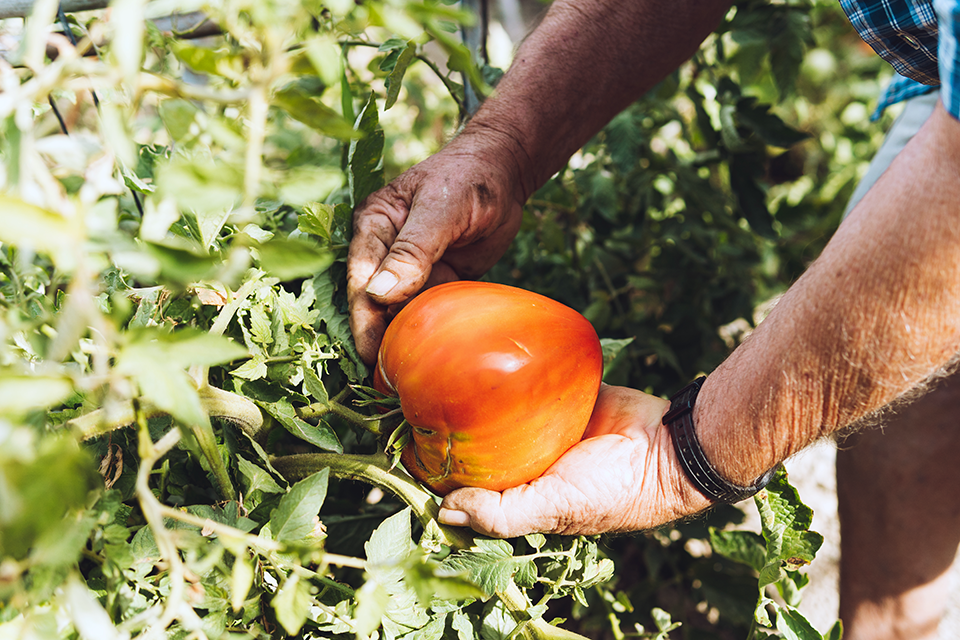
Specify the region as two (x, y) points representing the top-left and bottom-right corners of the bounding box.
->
(0, 0), (879, 640)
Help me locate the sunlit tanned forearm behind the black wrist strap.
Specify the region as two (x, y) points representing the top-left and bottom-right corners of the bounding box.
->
(694, 105), (960, 484)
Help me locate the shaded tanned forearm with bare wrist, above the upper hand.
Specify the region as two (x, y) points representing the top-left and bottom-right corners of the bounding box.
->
(460, 0), (731, 202)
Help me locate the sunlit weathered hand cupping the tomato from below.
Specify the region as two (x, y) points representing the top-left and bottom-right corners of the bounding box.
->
(440, 385), (710, 538)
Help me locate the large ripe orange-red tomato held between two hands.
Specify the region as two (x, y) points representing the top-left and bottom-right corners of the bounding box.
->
(374, 282), (603, 495)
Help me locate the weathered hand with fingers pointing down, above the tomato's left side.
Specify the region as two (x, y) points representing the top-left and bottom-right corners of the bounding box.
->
(347, 134), (526, 364)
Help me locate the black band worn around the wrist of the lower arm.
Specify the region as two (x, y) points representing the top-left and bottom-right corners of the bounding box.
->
(663, 377), (780, 504)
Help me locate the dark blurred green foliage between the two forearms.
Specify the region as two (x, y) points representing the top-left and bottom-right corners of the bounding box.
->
(491, 1), (892, 394)
